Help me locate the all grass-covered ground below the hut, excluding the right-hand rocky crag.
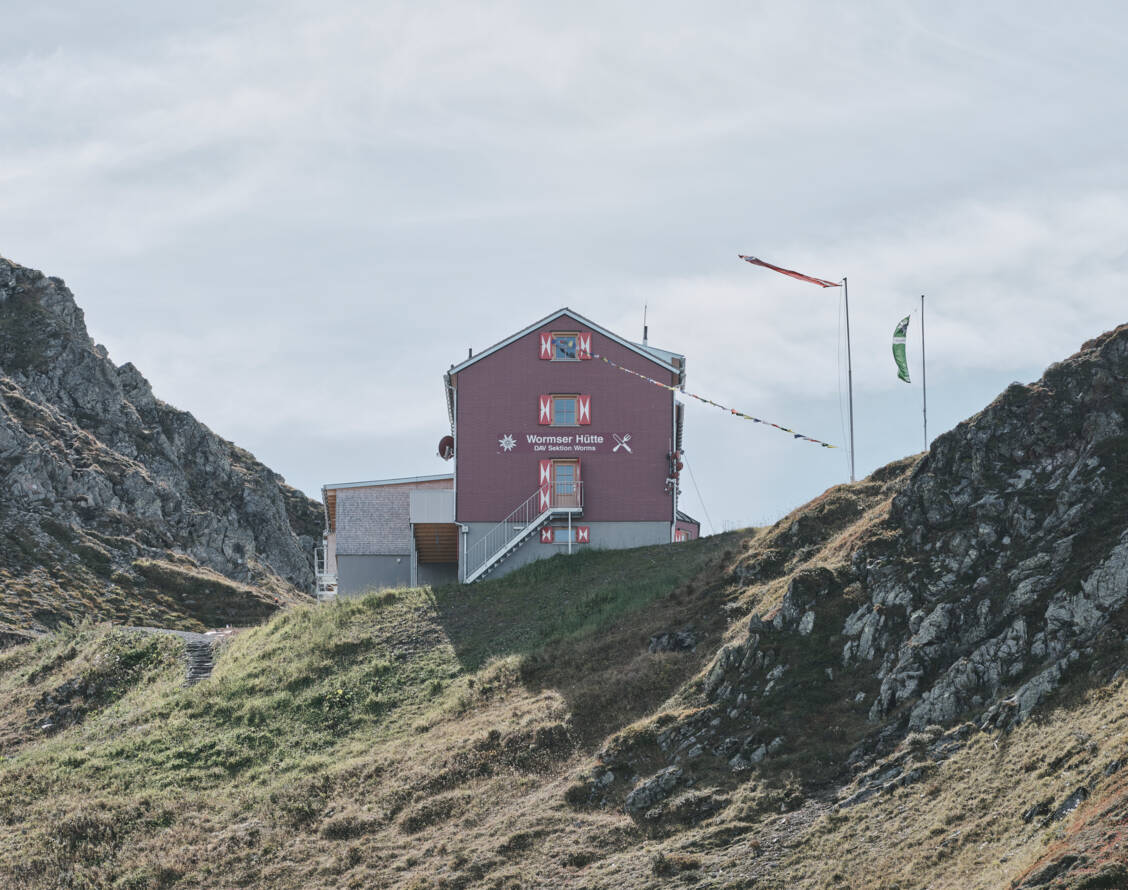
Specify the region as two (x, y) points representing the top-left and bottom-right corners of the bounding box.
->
(0, 471), (1128, 890)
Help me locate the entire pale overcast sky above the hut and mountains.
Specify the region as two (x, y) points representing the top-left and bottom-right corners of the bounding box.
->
(0, 0), (1128, 530)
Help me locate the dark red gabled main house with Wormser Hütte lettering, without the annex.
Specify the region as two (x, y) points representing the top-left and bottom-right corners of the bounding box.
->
(444, 309), (686, 581)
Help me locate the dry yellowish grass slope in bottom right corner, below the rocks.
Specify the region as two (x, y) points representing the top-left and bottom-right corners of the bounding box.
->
(773, 679), (1128, 890)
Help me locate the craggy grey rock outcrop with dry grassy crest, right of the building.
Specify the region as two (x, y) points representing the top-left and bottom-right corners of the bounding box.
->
(588, 326), (1128, 812)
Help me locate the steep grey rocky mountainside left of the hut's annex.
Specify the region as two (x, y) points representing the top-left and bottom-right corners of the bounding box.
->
(0, 258), (321, 627)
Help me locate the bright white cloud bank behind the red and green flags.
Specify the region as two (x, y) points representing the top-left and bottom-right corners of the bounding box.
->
(595, 191), (1128, 410)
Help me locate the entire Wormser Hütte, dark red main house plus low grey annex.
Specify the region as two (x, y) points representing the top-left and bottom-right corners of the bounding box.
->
(318, 309), (699, 594)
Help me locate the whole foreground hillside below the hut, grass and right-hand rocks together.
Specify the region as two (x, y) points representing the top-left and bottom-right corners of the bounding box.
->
(0, 313), (1128, 890)
